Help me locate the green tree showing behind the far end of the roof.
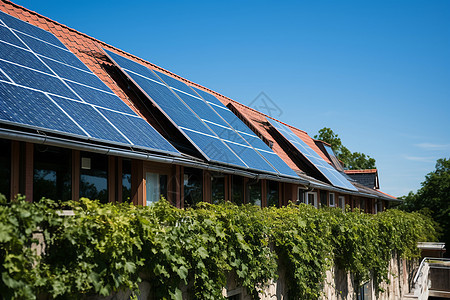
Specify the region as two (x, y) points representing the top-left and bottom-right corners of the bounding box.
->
(314, 127), (376, 170)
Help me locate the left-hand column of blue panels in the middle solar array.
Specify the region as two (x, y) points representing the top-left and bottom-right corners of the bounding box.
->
(104, 49), (249, 168)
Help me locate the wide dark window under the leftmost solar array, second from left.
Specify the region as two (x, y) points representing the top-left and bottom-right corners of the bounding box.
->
(33, 145), (72, 201)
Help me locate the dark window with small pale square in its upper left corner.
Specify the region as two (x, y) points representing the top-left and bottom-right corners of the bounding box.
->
(80, 152), (108, 203)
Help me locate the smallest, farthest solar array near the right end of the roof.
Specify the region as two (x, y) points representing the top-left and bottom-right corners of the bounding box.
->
(268, 119), (357, 191)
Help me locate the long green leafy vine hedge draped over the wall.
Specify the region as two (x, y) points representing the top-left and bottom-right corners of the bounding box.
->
(0, 197), (435, 299)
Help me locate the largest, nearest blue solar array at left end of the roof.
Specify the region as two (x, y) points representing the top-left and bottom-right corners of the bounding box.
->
(0, 12), (180, 155)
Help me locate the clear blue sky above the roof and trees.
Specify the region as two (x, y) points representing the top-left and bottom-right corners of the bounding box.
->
(16, 0), (450, 196)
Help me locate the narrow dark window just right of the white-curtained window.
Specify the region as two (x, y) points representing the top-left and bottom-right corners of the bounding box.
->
(184, 168), (203, 207)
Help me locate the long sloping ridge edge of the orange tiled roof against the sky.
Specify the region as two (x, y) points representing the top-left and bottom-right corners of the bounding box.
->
(0, 0), (308, 134)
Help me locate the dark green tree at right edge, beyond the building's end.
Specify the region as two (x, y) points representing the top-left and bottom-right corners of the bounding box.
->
(400, 158), (450, 256)
